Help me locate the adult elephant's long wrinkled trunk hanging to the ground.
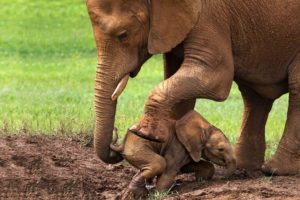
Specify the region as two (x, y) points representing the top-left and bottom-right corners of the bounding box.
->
(94, 64), (123, 164)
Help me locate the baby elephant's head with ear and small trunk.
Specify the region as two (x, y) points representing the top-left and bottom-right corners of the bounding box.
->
(176, 111), (236, 176)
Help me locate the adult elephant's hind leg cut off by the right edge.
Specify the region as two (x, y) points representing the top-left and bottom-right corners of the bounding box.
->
(263, 54), (300, 175)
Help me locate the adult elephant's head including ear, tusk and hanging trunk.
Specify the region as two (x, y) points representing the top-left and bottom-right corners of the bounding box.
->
(87, 0), (199, 163)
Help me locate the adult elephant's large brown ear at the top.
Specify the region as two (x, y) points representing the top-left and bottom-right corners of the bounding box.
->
(148, 0), (200, 54)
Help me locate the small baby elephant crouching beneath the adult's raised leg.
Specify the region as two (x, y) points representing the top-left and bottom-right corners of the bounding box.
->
(111, 111), (236, 196)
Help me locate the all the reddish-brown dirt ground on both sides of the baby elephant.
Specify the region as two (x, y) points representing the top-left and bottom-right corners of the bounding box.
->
(0, 136), (300, 200)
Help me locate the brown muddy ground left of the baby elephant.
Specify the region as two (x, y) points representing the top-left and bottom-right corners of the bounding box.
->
(0, 136), (135, 199)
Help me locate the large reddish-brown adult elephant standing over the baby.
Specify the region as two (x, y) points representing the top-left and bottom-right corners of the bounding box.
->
(87, 0), (300, 175)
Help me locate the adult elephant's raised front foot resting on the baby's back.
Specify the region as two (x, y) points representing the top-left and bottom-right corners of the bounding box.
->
(129, 115), (174, 143)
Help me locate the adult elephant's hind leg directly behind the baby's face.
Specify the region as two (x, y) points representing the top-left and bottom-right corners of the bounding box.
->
(236, 86), (273, 171)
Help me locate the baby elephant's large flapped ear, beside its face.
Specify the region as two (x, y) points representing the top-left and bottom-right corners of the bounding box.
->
(176, 111), (205, 162)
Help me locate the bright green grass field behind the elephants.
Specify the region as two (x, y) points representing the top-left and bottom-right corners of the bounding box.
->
(0, 0), (287, 157)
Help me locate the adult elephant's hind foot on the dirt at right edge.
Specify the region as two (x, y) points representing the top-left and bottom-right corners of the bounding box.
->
(262, 157), (300, 176)
